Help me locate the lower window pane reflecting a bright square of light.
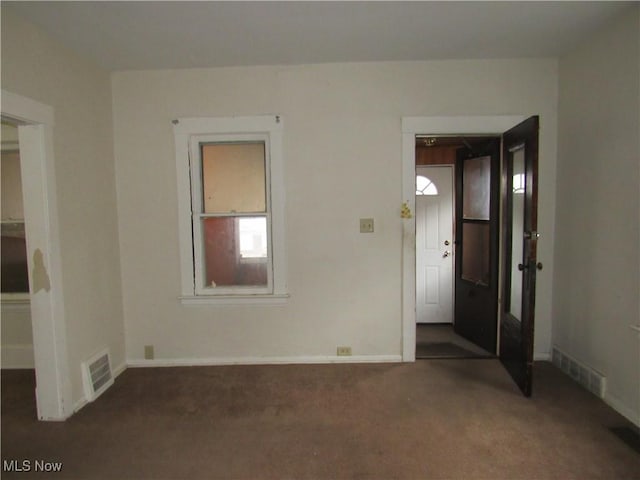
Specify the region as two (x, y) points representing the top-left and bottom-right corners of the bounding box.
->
(202, 216), (268, 287)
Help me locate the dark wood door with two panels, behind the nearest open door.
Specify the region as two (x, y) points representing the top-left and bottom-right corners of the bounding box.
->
(454, 138), (500, 354)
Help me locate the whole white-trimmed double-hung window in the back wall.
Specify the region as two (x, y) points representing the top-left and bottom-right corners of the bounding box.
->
(174, 116), (287, 303)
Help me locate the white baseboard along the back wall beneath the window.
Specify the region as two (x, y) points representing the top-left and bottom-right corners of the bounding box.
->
(127, 355), (402, 368)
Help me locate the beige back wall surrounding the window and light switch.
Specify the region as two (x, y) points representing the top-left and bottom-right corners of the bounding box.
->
(112, 59), (558, 361)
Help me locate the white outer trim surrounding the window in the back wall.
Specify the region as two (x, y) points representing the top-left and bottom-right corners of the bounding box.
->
(173, 115), (289, 305)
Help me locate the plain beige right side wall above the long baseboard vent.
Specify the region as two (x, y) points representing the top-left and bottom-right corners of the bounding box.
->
(553, 6), (640, 424)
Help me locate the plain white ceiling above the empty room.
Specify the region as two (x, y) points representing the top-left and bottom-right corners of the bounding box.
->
(2, 1), (632, 70)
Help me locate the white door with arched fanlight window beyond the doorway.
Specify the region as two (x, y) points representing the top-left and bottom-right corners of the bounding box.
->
(416, 166), (454, 323)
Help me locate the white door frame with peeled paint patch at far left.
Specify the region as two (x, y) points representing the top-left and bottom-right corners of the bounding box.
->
(1, 90), (73, 420)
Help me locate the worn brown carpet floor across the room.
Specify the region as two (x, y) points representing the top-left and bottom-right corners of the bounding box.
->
(2, 360), (640, 479)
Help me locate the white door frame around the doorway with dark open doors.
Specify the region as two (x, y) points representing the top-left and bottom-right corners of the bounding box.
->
(401, 115), (528, 362)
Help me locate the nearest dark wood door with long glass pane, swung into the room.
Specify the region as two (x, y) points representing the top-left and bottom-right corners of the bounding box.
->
(500, 116), (542, 396)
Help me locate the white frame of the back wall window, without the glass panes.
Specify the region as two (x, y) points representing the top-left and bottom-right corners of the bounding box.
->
(172, 115), (289, 304)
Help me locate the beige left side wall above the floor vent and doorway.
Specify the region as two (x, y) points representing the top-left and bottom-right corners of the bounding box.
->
(2, 6), (125, 402)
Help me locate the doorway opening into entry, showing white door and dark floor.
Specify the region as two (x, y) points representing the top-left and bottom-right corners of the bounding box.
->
(415, 135), (496, 359)
